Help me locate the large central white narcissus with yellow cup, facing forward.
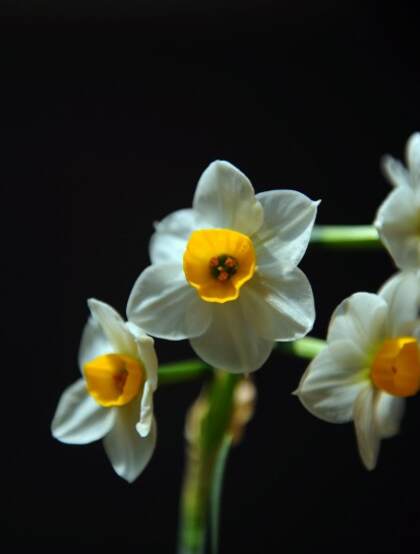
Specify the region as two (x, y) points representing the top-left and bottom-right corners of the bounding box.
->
(127, 161), (318, 373)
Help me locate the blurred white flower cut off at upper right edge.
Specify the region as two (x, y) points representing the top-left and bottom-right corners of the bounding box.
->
(375, 133), (420, 269)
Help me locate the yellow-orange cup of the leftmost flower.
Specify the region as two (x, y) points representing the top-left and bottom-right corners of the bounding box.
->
(83, 353), (145, 408)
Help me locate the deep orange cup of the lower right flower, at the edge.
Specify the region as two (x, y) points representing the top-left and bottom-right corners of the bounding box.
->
(371, 337), (420, 396)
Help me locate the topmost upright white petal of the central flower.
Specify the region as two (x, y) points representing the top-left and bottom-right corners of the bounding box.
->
(193, 160), (263, 235)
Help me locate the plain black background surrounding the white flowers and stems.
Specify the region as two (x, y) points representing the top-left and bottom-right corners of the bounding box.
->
(0, 0), (420, 554)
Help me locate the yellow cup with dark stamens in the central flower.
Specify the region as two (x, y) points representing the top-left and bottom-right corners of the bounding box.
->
(184, 229), (256, 304)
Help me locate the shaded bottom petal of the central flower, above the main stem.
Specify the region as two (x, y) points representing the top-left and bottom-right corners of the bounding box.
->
(191, 300), (273, 373)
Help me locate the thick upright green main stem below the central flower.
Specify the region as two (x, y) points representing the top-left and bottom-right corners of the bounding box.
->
(178, 372), (240, 554)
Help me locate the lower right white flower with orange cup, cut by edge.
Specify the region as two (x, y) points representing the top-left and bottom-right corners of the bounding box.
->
(296, 272), (420, 469)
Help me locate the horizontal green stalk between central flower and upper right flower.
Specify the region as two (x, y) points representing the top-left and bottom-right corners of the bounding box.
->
(311, 225), (382, 249)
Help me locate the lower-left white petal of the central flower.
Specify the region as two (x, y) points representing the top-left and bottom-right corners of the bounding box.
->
(127, 263), (211, 340)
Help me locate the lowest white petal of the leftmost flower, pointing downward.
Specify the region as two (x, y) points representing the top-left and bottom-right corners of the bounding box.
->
(104, 402), (156, 483)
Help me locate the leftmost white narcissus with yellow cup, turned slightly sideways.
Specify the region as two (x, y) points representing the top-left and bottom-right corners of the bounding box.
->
(51, 299), (157, 483)
